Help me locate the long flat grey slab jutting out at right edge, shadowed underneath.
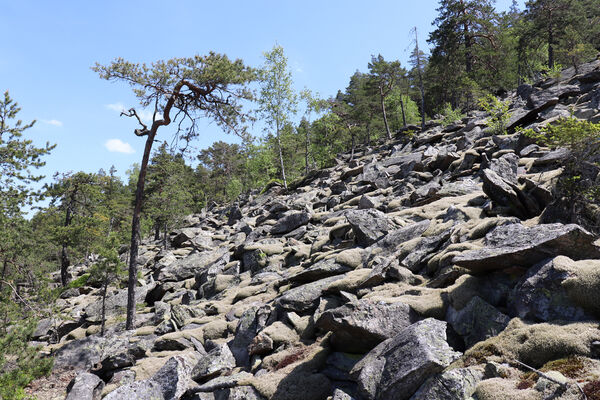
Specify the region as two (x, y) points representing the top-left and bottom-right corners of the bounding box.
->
(452, 224), (600, 273)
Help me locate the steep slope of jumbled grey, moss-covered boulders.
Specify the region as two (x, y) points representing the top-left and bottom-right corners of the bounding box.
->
(31, 61), (600, 400)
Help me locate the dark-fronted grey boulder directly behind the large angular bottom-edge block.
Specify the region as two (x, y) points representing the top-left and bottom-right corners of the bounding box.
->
(316, 300), (418, 353)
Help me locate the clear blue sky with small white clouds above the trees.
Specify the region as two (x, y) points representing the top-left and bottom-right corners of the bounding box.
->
(0, 0), (523, 187)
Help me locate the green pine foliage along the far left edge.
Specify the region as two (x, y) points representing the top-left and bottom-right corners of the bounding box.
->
(0, 92), (54, 399)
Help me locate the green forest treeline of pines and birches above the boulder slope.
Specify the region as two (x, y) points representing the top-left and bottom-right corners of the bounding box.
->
(0, 0), (600, 398)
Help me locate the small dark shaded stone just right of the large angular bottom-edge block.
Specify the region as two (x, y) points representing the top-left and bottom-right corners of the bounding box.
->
(446, 296), (510, 348)
